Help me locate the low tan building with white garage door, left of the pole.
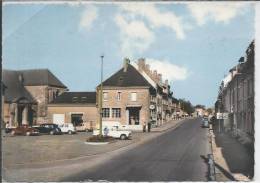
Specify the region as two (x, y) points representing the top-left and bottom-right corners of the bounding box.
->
(48, 92), (98, 129)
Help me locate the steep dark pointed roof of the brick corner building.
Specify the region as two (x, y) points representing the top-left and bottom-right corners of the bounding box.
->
(100, 64), (152, 87)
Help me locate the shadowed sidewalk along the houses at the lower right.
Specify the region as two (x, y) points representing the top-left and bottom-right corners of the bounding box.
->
(210, 128), (254, 181)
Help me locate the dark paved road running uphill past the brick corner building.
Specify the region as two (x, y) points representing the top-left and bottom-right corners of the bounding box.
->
(64, 119), (210, 181)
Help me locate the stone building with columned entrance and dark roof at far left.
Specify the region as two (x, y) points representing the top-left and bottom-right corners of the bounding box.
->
(2, 69), (67, 126)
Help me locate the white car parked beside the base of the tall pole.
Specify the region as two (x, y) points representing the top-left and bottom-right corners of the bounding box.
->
(93, 126), (132, 140)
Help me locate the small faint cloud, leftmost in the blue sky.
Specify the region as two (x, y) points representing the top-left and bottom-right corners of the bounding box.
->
(79, 4), (98, 30)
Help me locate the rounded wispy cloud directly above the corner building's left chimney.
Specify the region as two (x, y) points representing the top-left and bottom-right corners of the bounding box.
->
(115, 14), (154, 57)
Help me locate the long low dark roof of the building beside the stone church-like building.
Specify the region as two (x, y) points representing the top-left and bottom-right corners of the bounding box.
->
(51, 92), (96, 104)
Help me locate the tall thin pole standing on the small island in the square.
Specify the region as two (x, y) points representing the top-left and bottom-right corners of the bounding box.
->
(99, 55), (104, 136)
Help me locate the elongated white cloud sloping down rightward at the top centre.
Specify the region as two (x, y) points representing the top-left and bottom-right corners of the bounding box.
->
(120, 3), (185, 39)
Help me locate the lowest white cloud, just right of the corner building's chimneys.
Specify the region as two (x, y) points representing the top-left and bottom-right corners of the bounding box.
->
(145, 58), (189, 81)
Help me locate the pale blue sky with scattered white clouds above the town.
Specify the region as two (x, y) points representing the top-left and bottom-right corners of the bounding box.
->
(2, 2), (255, 107)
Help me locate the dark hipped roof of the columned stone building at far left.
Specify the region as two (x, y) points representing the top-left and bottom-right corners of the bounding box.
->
(16, 69), (67, 88)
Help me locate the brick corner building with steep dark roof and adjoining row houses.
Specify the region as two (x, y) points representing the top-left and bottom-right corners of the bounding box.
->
(97, 59), (174, 130)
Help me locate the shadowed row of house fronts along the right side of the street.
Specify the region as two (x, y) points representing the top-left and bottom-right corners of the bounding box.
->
(215, 41), (254, 143)
